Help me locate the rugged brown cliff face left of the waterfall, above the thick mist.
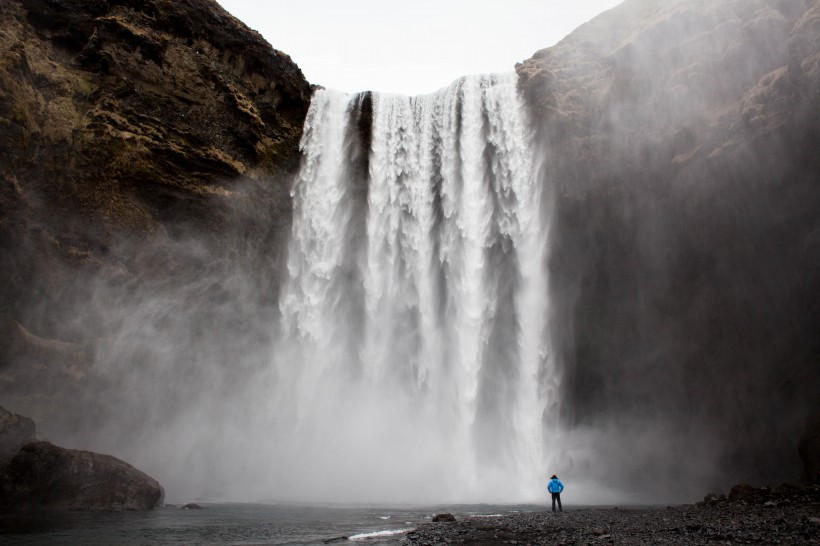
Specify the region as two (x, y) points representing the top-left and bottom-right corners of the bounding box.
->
(0, 0), (311, 428)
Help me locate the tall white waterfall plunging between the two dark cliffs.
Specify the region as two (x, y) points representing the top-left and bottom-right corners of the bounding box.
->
(271, 74), (552, 502)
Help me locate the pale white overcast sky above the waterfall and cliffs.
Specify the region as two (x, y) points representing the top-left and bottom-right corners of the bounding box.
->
(218, 0), (622, 95)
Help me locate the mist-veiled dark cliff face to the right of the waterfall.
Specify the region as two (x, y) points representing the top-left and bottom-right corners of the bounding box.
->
(517, 0), (820, 490)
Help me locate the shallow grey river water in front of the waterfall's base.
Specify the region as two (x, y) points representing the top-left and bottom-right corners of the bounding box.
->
(0, 503), (544, 545)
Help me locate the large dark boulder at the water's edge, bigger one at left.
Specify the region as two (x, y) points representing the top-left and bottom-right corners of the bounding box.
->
(0, 442), (164, 512)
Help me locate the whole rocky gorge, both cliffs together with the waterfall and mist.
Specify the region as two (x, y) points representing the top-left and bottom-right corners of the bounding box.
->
(0, 0), (820, 504)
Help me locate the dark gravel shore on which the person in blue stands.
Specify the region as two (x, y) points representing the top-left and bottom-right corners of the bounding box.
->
(402, 488), (820, 546)
